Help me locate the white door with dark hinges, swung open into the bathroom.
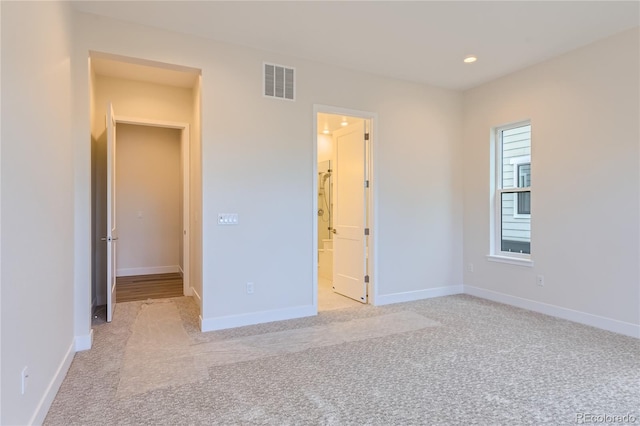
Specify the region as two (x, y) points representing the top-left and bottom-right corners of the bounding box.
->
(333, 121), (367, 303)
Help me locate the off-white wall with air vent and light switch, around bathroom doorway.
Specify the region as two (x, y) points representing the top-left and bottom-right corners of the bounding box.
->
(74, 14), (462, 328)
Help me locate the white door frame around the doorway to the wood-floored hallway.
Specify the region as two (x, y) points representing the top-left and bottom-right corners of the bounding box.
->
(115, 115), (193, 296)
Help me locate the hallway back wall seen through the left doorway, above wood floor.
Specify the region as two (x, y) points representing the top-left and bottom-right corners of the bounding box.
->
(116, 123), (182, 276)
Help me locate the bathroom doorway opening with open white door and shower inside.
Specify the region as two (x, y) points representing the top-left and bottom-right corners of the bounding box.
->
(314, 107), (374, 311)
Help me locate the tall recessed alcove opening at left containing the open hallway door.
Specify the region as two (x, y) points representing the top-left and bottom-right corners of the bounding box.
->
(90, 52), (202, 320)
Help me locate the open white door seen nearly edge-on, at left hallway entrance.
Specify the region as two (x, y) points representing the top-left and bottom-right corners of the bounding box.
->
(105, 103), (118, 322)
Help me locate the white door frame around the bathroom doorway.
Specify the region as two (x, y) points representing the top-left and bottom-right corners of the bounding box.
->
(311, 104), (378, 313)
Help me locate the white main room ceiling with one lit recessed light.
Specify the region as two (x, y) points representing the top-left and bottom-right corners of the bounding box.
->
(72, 1), (640, 90)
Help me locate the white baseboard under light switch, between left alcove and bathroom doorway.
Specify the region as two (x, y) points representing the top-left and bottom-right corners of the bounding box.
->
(200, 305), (317, 331)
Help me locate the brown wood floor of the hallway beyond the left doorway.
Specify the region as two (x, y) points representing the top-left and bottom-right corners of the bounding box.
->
(116, 273), (183, 303)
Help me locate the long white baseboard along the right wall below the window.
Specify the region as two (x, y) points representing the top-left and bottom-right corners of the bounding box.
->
(464, 285), (640, 338)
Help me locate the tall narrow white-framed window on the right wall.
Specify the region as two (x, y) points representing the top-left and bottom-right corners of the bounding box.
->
(491, 122), (531, 260)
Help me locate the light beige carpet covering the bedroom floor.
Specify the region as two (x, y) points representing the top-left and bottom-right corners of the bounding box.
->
(45, 295), (640, 425)
